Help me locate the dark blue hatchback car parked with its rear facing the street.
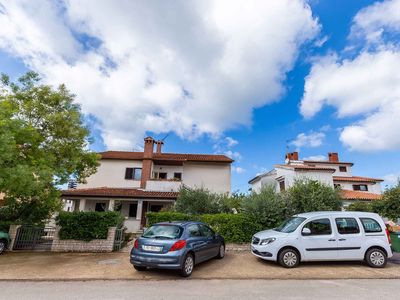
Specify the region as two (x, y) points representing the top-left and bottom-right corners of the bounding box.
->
(130, 222), (225, 277)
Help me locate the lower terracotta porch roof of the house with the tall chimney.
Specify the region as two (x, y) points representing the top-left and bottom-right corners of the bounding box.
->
(61, 187), (179, 199)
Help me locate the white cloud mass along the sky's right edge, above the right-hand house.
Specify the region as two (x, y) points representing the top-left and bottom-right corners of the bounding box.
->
(300, 1), (400, 151)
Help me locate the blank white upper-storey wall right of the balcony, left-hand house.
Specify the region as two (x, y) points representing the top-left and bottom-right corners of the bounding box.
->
(182, 162), (231, 193)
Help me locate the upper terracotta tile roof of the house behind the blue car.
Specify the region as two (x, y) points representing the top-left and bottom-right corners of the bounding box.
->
(99, 151), (233, 163)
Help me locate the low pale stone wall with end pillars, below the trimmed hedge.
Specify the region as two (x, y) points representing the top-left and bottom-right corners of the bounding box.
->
(51, 227), (117, 252)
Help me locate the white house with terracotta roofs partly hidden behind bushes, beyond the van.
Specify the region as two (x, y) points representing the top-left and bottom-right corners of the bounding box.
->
(249, 152), (383, 206)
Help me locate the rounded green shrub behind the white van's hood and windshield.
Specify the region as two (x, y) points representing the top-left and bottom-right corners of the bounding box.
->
(243, 185), (287, 228)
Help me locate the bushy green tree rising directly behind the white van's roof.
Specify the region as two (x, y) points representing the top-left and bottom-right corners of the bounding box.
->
(283, 179), (342, 214)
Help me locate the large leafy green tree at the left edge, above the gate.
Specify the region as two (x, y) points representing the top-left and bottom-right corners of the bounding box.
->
(0, 72), (98, 223)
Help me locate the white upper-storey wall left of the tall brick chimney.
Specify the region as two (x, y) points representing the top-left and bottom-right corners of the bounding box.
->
(77, 159), (142, 189)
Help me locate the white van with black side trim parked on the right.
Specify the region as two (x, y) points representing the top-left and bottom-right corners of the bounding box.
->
(251, 211), (393, 268)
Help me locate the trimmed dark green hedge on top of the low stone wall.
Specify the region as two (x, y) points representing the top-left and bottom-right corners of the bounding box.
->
(56, 211), (124, 241)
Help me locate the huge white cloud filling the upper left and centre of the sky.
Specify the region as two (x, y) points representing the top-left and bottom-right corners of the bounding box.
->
(0, 0), (320, 149)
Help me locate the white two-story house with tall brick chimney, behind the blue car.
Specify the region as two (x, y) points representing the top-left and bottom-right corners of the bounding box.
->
(62, 137), (233, 232)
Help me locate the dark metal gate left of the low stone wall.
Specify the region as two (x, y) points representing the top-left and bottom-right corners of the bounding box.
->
(14, 226), (55, 251)
